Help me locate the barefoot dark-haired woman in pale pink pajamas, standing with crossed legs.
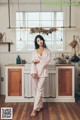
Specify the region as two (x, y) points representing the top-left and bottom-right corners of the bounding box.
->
(31, 35), (51, 116)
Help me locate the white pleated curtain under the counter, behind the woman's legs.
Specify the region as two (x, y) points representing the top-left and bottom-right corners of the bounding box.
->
(24, 73), (56, 97)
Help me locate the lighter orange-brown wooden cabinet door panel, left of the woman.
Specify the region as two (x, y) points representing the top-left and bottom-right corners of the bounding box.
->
(8, 69), (22, 96)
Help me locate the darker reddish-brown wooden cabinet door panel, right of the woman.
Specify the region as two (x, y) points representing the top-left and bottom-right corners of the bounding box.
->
(58, 68), (72, 96)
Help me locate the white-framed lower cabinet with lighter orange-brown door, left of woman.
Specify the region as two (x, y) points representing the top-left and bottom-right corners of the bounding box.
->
(5, 64), (24, 102)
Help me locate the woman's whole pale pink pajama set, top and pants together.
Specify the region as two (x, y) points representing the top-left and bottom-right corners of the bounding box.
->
(31, 48), (51, 111)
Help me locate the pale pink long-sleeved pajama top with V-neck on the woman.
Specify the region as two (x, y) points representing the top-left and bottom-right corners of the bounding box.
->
(31, 48), (51, 77)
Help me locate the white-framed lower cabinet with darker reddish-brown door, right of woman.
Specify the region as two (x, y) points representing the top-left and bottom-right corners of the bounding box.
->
(56, 65), (75, 102)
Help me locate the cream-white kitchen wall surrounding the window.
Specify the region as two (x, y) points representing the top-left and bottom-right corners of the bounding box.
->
(0, 0), (80, 94)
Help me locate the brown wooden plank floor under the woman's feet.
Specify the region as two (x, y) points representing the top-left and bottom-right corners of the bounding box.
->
(0, 96), (80, 120)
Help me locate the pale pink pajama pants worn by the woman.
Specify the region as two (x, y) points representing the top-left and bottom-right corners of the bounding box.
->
(33, 77), (45, 111)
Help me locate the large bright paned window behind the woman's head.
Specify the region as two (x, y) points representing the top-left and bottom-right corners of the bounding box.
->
(16, 12), (63, 51)
